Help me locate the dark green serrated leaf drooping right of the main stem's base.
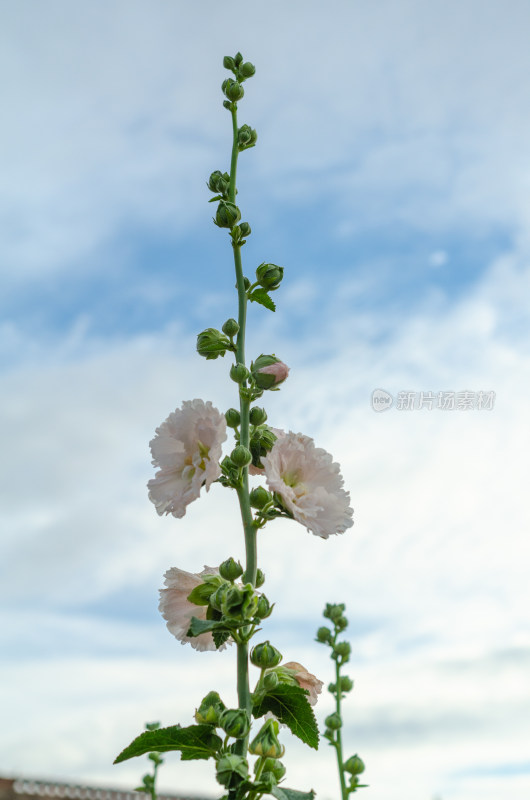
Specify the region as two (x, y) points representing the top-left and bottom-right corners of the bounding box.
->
(253, 683), (319, 750)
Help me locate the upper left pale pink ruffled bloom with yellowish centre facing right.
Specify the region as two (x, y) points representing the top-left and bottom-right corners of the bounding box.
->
(147, 400), (226, 517)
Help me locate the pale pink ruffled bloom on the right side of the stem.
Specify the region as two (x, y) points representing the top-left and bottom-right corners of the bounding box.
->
(261, 432), (353, 539)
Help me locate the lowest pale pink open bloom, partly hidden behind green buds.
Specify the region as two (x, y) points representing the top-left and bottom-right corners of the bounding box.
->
(158, 566), (226, 650)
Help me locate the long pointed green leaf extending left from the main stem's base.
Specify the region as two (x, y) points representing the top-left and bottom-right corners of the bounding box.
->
(114, 725), (223, 764)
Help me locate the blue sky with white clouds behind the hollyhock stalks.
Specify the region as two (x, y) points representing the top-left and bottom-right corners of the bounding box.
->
(0, 0), (530, 800)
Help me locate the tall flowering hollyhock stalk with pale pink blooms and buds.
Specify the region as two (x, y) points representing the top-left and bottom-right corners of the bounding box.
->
(116, 53), (353, 800)
